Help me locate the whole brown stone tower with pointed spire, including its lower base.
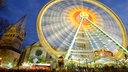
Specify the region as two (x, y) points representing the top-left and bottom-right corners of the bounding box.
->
(0, 16), (26, 67)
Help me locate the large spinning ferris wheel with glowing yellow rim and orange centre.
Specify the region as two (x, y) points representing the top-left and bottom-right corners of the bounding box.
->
(37, 0), (128, 60)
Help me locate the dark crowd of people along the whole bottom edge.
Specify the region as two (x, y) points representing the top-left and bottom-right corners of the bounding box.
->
(0, 66), (128, 72)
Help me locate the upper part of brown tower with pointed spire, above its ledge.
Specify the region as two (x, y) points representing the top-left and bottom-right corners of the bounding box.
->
(0, 16), (26, 51)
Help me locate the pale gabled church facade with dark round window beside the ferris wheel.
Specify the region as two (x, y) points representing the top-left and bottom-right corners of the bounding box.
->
(18, 41), (58, 68)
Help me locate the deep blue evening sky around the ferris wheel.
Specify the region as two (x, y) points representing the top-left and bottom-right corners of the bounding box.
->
(0, 0), (128, 48)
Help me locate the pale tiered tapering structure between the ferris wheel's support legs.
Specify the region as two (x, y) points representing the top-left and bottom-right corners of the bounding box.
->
(70, 28), (93, 61)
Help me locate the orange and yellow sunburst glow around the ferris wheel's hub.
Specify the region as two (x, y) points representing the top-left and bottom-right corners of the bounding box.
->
(66, 6), (98, 28)
